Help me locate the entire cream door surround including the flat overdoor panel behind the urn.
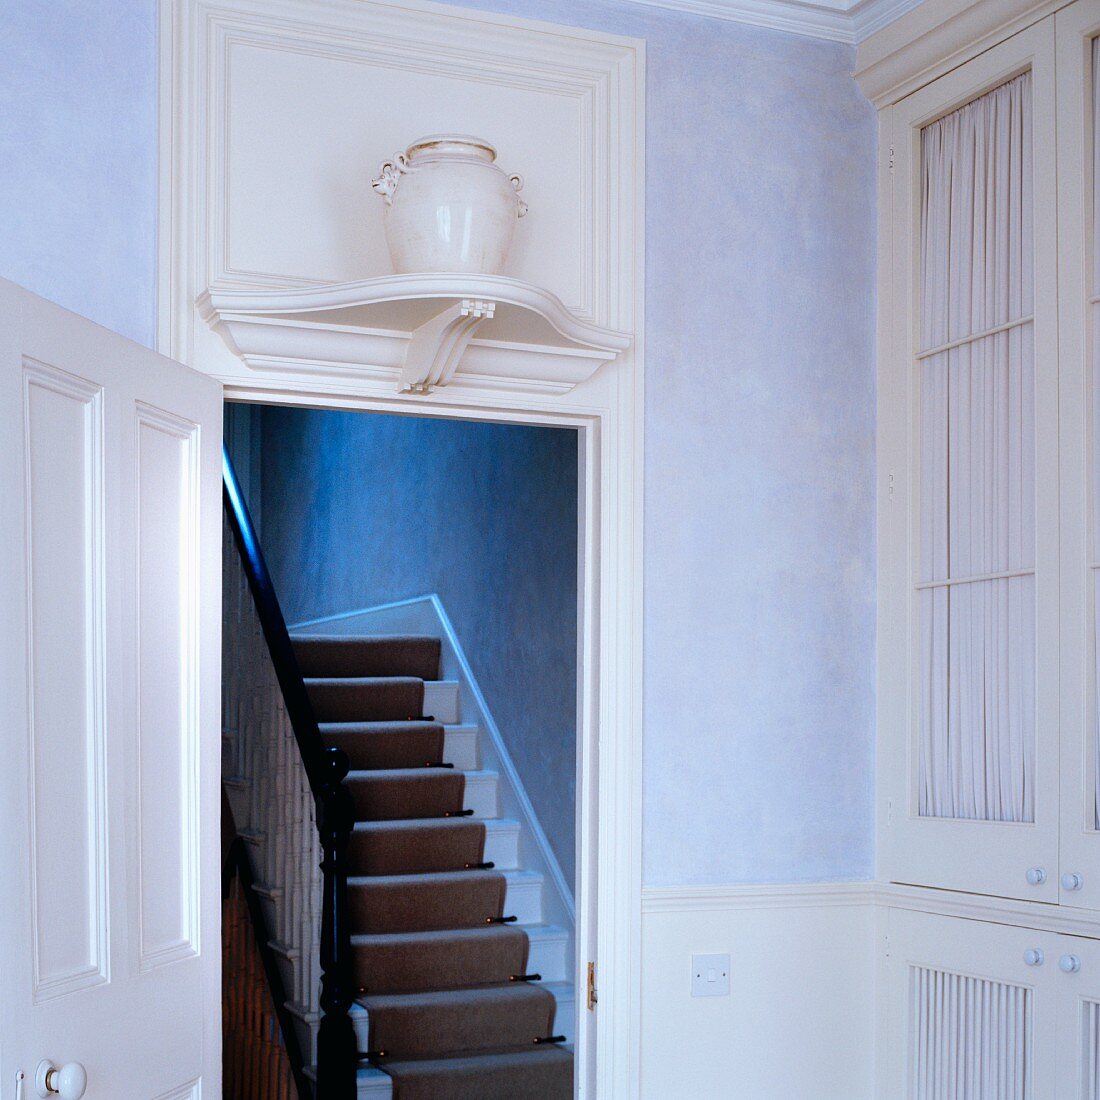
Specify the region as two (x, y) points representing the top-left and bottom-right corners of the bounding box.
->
(158, 0), (645, 1100)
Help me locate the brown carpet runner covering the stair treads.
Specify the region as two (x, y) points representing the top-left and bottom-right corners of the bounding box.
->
(294, 636), (573, 1100)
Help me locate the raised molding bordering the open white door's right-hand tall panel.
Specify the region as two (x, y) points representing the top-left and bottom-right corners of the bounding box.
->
(134, 402), (201, 971)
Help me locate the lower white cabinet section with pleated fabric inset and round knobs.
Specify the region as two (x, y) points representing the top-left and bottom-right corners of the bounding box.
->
(880, 910), (1100, 1100)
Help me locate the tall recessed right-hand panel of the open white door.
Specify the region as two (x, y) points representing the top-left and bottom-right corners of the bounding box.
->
(136, 404), (199, 970)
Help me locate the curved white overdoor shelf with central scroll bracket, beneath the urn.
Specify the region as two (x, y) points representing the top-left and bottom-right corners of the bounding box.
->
(198, 273), (631, 394)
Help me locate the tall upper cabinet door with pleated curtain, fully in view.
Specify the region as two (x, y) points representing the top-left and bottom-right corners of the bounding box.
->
(879, 19), (1059, 901)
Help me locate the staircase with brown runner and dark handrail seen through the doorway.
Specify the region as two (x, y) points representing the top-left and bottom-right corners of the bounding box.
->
(222, 466), (575, 1100)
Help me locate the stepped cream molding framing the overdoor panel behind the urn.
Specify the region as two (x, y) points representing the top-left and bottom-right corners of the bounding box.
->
(158, 0), (636, 374)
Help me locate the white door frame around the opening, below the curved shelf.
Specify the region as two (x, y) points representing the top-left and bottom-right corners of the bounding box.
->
(215, 371), (642, 1098)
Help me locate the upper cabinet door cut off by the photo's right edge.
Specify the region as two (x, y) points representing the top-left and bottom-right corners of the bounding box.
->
(1055, 0), (1100, 909)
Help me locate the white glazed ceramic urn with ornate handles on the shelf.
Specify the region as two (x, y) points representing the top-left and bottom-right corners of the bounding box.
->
(371, 134), (527, 275)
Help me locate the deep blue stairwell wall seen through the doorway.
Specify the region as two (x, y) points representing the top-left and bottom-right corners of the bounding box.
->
(260, 408), (578, 882)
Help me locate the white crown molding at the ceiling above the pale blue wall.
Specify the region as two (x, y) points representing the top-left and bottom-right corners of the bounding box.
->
(611, 0), (922, 45)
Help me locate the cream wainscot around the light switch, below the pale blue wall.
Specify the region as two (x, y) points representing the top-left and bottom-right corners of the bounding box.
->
(641, 883), (875, 1100)
